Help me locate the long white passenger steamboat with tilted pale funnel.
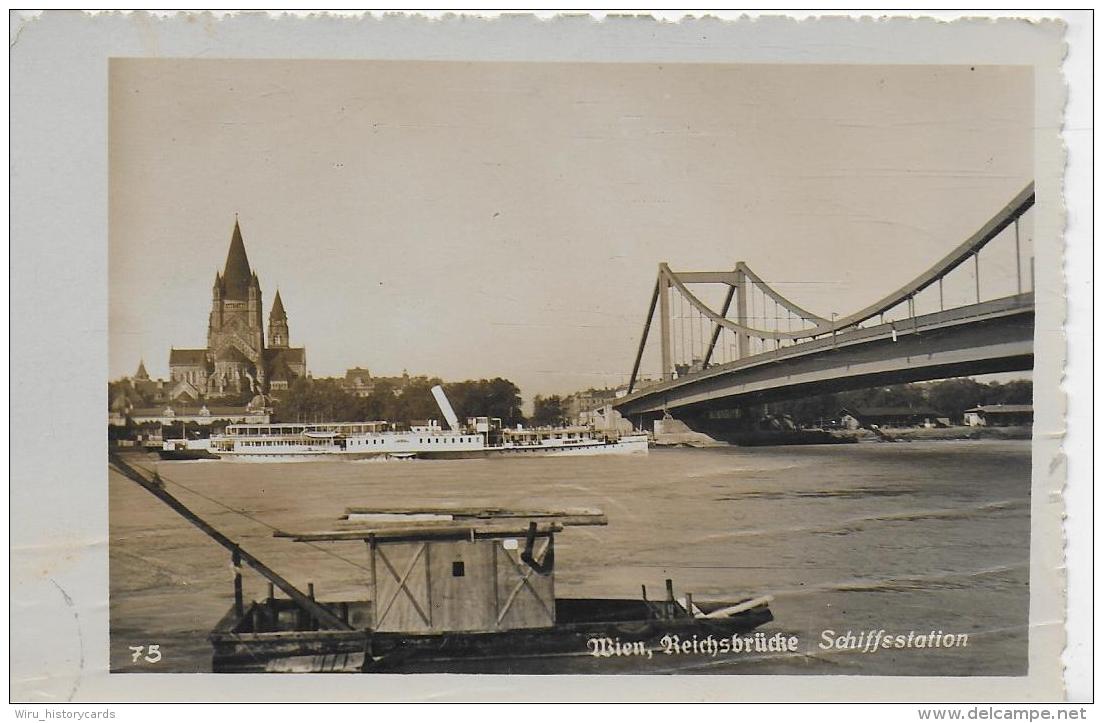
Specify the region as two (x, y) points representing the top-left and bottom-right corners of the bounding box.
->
(201, 385), (647, 461)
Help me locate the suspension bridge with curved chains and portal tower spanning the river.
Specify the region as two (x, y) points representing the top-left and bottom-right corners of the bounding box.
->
(613, 183), (1035, 425)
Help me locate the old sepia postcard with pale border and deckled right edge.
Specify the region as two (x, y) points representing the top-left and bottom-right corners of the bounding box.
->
(11, 13), (1080, 701)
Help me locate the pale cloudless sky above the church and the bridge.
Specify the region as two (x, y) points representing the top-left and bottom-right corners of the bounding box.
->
(108, 60), (1034, 397)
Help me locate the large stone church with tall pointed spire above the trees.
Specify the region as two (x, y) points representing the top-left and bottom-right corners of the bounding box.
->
(169, 219), (307, 401)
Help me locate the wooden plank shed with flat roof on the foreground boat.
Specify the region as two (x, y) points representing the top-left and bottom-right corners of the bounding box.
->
(275, 508), (607, 634)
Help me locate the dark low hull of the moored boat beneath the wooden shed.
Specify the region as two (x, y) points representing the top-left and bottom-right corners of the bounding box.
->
(211, 599), (773, 674)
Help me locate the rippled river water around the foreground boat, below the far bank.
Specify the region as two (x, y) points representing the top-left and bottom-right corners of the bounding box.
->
(109, 440), (1030, 676)
